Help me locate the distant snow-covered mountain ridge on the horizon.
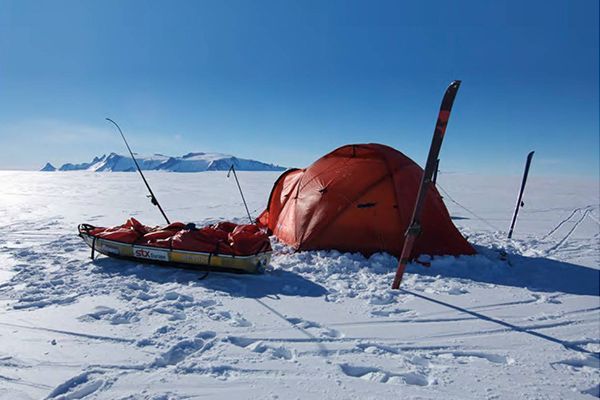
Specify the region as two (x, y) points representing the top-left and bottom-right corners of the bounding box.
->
(41, 152), (285, 172)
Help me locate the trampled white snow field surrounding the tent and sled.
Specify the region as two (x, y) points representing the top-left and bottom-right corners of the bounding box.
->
(0, 172), (600, 400)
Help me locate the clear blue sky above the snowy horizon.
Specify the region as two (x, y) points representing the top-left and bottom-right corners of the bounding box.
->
(0, 0), (600, 177)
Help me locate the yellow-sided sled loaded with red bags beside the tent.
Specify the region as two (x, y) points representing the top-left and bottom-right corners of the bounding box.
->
(78, 218), (272, 273)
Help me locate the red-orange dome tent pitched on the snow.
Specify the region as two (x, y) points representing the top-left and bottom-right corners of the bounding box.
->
(258, 143), (475, 257)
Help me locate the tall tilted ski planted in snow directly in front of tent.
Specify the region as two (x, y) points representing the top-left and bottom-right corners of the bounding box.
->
(392, 81), (460, 289)
